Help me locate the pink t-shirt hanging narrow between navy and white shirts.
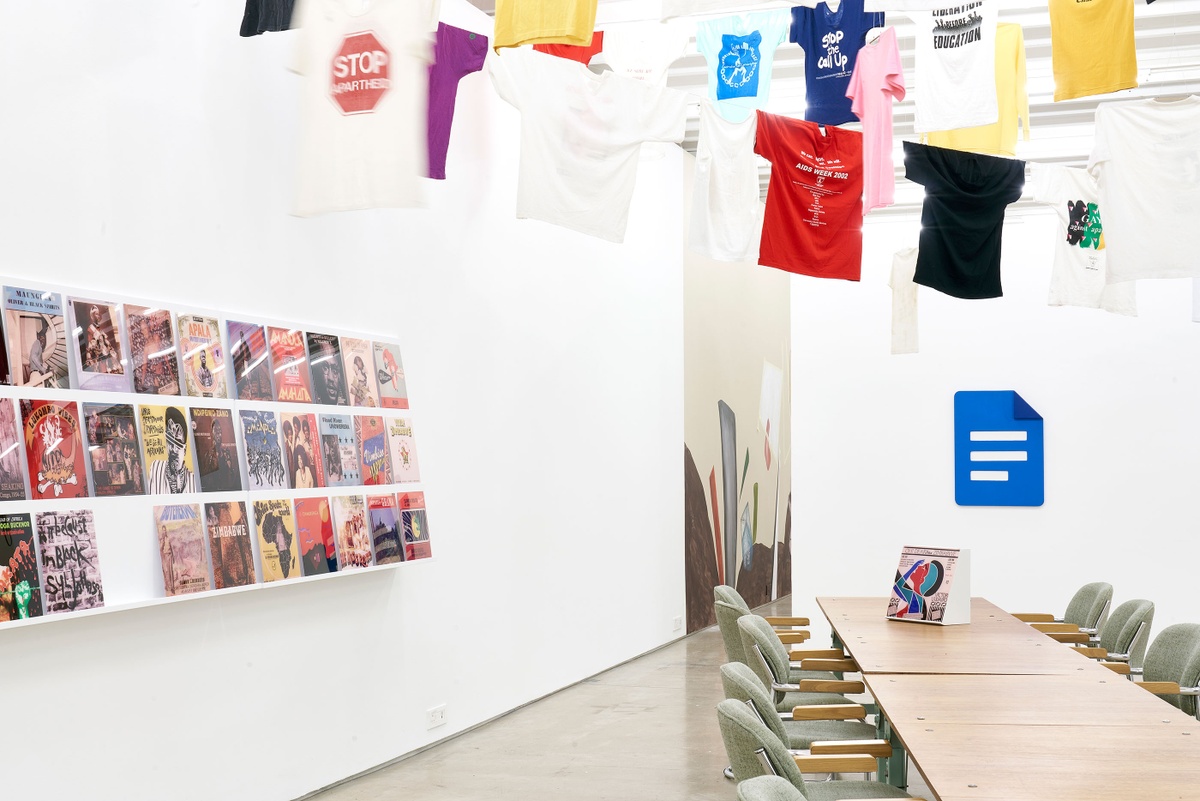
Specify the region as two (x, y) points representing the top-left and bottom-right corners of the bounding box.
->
(846, 28), (905, 213)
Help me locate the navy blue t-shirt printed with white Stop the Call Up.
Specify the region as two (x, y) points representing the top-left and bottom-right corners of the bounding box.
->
(790, 0), (883, 125)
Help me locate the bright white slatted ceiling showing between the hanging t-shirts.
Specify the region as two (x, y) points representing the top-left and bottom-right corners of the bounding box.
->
(470, 0), (1200, 217)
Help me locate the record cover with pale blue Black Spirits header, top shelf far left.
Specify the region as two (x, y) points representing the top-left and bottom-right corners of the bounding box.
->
(4, 287), (71, 390)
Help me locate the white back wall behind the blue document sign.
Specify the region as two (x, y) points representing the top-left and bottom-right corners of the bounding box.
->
(792, 208), (1200, 639)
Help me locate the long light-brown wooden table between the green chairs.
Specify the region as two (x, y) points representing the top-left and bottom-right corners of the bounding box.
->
(818, 598), (1200, 801)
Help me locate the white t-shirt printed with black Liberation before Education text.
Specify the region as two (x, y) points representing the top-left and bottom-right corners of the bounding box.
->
(908, 0), (1000, 133)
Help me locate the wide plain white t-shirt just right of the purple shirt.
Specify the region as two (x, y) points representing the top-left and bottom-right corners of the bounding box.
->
(487, 49), (686, 242)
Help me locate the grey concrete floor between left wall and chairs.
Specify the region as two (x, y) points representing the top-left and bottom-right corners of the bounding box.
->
(310, 598), (932, 801)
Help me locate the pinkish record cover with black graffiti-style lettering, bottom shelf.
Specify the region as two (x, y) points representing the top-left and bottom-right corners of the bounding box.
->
(34, 508), (104, 615)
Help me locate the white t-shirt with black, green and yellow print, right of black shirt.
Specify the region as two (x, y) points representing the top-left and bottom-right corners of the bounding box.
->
(1026, 162), (1138, 317)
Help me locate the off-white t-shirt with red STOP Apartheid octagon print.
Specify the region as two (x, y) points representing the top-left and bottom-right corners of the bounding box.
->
(292, 0), (439, 217)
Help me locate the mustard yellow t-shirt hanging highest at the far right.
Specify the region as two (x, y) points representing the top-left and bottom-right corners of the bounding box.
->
(1050, 0), (1138, 101)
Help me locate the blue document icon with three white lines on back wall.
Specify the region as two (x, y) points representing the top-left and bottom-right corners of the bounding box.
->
(954, 390), (1045, 506)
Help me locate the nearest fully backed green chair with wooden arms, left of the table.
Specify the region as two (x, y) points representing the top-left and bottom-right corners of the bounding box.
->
(716, 698), (912, 801)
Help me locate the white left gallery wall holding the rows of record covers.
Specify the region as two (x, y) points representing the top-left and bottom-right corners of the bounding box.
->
(0, 0), (683, 801)
